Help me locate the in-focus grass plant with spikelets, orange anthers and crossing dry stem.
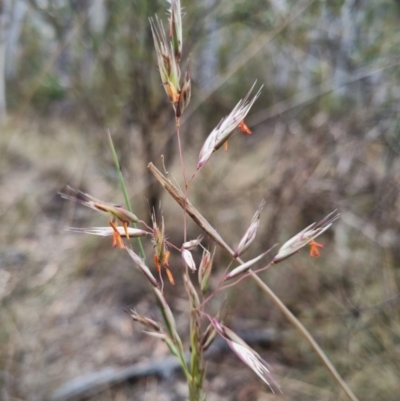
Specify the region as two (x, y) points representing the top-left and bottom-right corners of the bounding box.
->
(61, 0), (357, 401)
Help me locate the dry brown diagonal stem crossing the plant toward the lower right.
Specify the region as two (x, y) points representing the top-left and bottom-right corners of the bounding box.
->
(148, 163), (358, 401)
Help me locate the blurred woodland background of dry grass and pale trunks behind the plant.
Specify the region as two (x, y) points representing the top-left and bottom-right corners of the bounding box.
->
(0, 0), (400, 401)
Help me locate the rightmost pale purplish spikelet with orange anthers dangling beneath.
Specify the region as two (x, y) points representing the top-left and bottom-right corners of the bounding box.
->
(273, 210), (340, 263)
